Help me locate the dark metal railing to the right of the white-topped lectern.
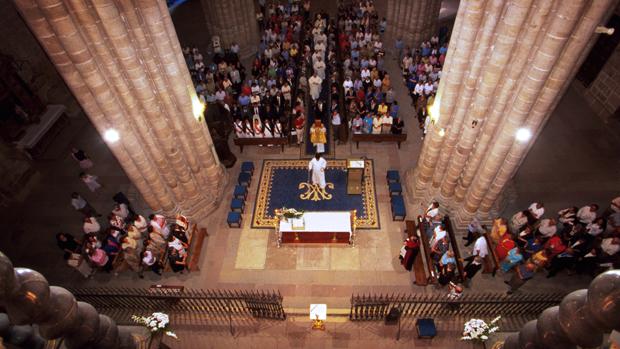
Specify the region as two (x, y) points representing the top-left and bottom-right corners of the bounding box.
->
(349, 293), (564, 321)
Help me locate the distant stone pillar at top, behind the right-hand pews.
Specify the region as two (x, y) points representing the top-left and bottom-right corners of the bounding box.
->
(386, 0), (441, 47)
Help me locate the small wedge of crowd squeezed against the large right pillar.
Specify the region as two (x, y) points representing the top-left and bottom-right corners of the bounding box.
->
(395, 36), (448, 138)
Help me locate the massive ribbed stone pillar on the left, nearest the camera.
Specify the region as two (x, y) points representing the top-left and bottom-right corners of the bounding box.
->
(15, 0), (224, 219)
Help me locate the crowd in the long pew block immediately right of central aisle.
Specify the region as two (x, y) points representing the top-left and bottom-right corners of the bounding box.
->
(338, 0), (405, 134)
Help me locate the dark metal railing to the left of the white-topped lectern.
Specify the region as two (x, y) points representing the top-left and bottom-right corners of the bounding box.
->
(71, 286), (286, 320)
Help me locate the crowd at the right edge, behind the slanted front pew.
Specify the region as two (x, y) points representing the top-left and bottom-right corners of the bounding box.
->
(490, 197), (620, 292)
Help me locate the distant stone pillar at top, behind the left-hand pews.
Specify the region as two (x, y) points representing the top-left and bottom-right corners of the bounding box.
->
(201, 0), (259, 58)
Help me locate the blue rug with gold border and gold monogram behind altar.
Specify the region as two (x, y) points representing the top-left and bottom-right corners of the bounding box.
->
(252, 160), (380, 229)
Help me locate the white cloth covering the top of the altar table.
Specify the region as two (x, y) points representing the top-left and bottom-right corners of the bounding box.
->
(280, 211), (351, 235)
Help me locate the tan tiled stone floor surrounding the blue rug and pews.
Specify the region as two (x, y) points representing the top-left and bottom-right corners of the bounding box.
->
(0, 2), (620, 348)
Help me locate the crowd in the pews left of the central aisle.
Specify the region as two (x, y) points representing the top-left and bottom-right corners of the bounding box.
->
(183, 3), (304, 138)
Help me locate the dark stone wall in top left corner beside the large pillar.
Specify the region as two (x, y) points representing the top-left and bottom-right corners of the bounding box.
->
(0, 0), (84, 117)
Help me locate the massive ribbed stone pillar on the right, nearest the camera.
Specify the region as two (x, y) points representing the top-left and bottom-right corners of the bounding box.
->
(407, 0), (616, 223)
